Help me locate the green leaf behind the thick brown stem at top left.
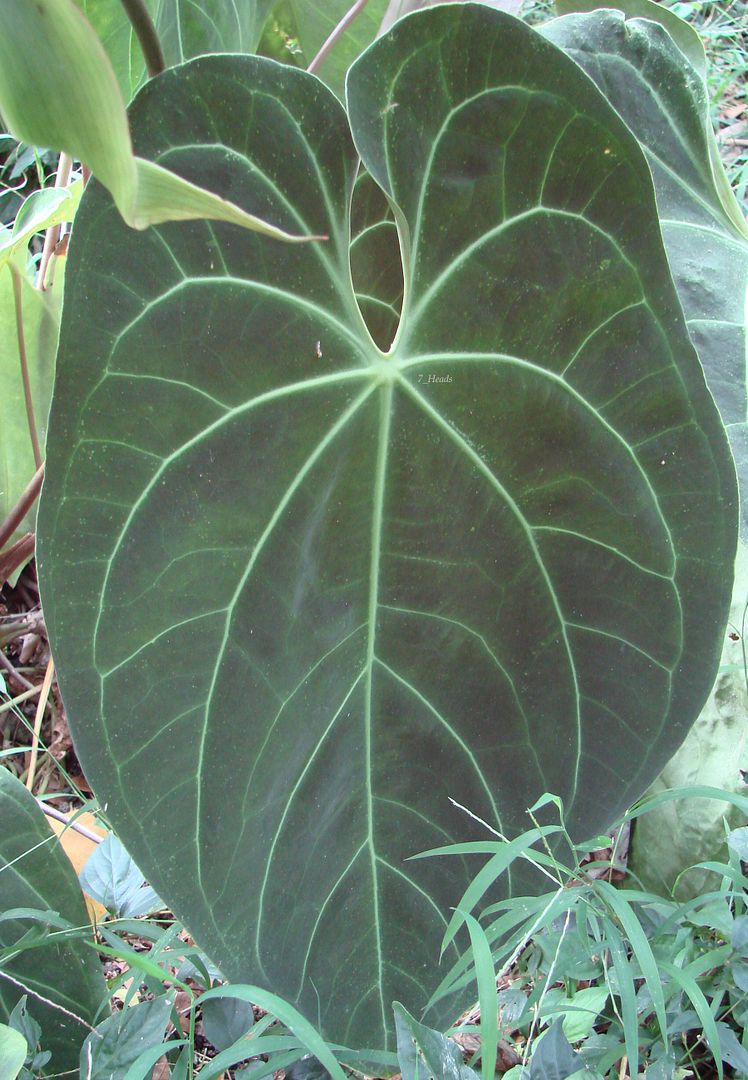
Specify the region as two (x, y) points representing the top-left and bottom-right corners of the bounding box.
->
(76, 0), (273, 102)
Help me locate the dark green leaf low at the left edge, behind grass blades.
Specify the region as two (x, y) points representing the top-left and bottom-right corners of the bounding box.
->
(0, 768), (107, 1075)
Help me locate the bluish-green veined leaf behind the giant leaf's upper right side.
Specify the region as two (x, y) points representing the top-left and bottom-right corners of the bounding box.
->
(542, 0), (748, 538)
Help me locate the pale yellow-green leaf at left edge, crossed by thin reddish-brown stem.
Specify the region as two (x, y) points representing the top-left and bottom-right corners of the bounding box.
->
(0, 264), (60, 532)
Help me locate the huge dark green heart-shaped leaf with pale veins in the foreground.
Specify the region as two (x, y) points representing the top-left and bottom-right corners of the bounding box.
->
(40, 4), (736, 1047)
